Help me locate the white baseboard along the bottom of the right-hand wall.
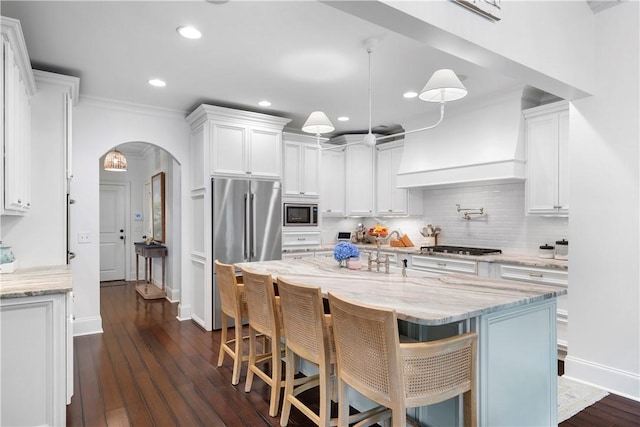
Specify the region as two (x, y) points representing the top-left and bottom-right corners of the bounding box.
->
(564, 355), (640, 402)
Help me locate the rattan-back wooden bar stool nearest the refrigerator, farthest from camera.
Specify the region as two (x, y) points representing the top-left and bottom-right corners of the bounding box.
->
(214, 260), (249, 385)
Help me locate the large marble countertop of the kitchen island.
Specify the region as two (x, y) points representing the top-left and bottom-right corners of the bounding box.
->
(235, 258), (567, 325)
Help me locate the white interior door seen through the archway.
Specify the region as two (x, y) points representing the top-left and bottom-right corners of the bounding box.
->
(100, 184), (126, 282)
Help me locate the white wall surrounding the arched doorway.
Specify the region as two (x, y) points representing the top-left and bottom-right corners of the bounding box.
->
(70, 98), (189, 335)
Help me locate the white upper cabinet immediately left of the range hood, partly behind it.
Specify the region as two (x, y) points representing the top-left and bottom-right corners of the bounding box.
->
(375, 141), (423, 216)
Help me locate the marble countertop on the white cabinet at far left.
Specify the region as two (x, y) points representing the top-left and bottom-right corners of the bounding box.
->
(0, 265), (73, 298)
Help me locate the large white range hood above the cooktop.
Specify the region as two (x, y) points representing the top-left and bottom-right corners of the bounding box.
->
(397, 87), (536, 188)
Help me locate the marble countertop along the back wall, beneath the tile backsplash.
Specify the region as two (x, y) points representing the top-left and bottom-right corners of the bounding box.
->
(284, 244), (569, 271)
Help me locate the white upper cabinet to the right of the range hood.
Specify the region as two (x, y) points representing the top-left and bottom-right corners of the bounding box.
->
(523, 102), (569, 216)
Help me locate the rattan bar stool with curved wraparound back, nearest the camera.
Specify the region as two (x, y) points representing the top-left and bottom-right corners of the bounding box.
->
(329, 293), (477, 427)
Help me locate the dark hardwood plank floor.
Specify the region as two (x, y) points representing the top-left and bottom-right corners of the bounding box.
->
(67, 284), (640, 427)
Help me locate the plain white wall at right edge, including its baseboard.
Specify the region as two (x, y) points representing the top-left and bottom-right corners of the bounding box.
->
(565, 1), (640, 400)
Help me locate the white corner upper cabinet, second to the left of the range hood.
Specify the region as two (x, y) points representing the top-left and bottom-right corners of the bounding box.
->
(346, 144), (375, 217)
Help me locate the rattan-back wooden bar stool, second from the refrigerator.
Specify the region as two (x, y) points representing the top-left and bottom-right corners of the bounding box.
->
(242, 268), (284, 417)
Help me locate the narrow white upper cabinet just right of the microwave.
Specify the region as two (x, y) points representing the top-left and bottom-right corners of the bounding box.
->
(320, 147), (347, 217)
